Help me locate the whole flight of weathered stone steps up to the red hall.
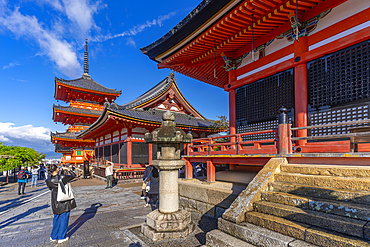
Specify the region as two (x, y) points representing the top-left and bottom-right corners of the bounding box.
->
(207, 164), (370, 247)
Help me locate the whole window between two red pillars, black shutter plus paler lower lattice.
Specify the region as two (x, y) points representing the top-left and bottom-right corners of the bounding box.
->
(235, 69), (294, 141)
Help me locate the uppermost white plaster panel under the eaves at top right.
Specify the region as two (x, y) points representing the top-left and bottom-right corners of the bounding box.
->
(310, 0), (370, 35)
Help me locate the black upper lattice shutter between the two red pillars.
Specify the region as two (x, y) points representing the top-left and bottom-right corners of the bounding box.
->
(236, 69), (294, 125)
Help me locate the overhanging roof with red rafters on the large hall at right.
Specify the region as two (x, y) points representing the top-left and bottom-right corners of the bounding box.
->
(141, 0), (332, 90)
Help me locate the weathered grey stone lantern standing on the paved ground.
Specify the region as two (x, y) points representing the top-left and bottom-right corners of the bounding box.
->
(141, 111), (194, 241)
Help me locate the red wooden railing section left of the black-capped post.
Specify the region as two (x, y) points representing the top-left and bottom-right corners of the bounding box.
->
(189, 129), (277, 155)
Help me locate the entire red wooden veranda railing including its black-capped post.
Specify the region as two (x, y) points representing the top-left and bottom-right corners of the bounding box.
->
(188, 112), (370, 155)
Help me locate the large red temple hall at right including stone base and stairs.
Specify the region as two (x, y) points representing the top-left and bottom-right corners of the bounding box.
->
(141, 0), (370, 247)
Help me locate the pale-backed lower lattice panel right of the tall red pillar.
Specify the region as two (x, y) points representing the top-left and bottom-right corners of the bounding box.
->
(309, 103), (370, 136)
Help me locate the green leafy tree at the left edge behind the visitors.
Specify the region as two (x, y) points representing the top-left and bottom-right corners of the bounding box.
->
(0, 142), (46, 171)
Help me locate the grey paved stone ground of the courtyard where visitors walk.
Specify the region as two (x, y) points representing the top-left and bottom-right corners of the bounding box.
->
(0, 179), (217, 247)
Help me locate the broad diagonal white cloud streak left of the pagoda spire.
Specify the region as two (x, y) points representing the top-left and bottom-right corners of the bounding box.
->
(0, 8), (82, 77)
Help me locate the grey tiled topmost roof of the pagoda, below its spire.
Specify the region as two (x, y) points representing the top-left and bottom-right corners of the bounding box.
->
(55, 75), (122, 95)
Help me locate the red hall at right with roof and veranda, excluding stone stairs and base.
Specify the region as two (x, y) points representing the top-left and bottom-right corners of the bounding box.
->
(141, 0), (370, 178)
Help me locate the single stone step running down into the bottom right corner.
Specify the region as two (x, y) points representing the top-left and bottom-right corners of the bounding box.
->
(246, 212), (370, 247)
